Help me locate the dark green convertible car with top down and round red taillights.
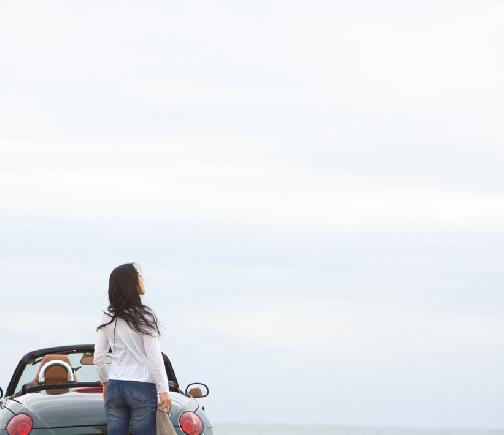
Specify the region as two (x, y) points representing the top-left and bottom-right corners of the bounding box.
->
(0, 344), (213, 435)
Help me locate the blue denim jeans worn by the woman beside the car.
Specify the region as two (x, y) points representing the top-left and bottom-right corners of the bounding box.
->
(105, 379), (157, 435)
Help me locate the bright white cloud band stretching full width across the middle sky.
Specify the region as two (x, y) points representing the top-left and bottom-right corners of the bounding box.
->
(0, 147), (504, 235)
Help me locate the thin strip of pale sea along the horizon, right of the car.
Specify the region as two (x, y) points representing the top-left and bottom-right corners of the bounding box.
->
(213, 424), (504, 435)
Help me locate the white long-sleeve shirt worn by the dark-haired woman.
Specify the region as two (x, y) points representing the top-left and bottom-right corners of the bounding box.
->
(94, 311), (169, 393)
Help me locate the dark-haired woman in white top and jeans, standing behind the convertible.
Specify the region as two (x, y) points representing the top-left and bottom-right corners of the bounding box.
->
(94, 263), (171, 435)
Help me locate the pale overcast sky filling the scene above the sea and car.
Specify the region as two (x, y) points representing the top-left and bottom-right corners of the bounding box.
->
(0, 0), (504, 428)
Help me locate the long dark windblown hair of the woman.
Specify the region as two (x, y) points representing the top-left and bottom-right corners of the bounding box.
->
(96, 263), (160, 338)
